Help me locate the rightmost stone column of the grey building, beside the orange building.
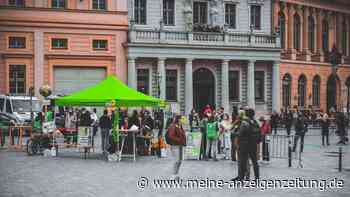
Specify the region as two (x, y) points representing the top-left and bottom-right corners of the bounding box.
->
(272, 61), (281, 112)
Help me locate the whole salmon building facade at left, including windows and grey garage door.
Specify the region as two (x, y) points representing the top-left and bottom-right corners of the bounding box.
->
(0, 0), (128, 95)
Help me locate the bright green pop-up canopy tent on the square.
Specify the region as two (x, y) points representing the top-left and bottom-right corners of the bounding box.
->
(55, 76), (166, 151)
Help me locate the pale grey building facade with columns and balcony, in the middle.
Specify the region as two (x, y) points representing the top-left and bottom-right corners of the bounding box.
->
(126, 0), (280, 114)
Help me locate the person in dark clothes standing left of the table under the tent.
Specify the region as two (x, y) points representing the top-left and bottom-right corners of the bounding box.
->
(99, 109), (112, 156)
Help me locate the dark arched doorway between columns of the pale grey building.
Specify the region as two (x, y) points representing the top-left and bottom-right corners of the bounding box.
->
(193, 68), (215, 111)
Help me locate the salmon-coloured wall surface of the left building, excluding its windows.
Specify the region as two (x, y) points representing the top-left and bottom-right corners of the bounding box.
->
(0, 0), (128, 94)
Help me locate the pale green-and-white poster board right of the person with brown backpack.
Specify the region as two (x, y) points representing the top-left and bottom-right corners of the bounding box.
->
(185, 132), (202, 160)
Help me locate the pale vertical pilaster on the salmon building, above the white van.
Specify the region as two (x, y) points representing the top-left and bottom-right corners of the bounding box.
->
(34, 31), (44, 96)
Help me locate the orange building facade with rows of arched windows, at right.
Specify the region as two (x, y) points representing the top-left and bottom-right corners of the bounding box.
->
(273, 0), (350, 111)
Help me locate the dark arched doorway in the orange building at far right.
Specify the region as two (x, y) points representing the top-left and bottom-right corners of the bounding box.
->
(327, 75), (340, 112)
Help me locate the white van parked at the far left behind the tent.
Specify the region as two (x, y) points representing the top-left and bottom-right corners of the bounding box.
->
(0, 95), (41, 123)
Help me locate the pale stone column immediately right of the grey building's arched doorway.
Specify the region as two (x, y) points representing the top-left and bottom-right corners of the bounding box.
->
(221, 59), (230, 112)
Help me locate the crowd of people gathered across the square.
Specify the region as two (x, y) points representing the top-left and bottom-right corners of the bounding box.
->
(31, 105), (348, 180)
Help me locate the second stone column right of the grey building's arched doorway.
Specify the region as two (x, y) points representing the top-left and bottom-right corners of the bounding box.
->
(247, 60), (255, 109)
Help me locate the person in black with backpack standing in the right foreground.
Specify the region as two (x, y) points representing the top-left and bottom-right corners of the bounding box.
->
(232, 109), (260, 181)
